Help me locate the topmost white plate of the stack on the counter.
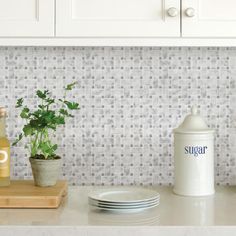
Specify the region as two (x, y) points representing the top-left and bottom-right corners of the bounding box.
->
(89, 187), (160, 204)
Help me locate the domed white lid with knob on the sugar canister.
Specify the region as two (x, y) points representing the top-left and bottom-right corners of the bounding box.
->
(174, 106), (214, 133)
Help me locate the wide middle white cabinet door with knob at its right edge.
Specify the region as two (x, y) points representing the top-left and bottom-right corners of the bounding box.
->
(56, 0), (180, 37)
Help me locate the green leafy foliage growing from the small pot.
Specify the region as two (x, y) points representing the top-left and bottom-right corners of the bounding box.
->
(13, 82), (80, 159)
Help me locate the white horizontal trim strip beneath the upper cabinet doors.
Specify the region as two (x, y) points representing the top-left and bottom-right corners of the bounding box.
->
(0, 37), (236, 47)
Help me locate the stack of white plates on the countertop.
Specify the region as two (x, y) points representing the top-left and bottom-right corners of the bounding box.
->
(89, 187), (160, 212)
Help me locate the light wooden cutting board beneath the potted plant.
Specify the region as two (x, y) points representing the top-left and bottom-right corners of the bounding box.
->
(0, 180), (67, 208)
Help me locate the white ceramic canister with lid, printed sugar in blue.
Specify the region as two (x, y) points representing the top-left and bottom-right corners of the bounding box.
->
(174, 106), (215, 196)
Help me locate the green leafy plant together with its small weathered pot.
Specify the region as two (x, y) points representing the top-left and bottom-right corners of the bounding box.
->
(13, 83), (79, 187)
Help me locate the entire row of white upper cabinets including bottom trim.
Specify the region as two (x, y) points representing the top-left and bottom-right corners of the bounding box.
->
(0, 0), (236, 46)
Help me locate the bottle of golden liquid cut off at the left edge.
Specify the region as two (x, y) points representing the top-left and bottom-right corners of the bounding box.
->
(0, 107), (10, 187)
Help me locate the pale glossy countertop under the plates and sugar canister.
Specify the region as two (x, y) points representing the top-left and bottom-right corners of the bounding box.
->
(0, 187), (236, 236)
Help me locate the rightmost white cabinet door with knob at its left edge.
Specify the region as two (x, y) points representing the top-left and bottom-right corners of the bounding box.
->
(182, 0), (236, 37)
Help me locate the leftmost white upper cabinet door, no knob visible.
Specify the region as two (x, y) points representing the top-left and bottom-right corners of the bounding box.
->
(0, 0), (54, 37)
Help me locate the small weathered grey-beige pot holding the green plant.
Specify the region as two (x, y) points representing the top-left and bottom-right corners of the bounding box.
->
(29, 158), (61, 187)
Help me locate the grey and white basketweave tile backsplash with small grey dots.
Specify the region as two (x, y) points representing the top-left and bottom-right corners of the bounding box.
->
(0, 47), (236, 185)
